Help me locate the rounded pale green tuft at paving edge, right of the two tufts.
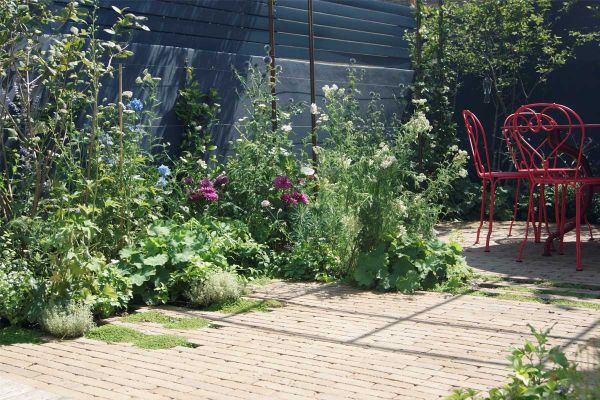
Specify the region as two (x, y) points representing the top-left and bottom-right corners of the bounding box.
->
(186, 271), (244, 306)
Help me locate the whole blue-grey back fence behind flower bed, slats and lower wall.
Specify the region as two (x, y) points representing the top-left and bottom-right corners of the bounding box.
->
(55, 0), (415, 154)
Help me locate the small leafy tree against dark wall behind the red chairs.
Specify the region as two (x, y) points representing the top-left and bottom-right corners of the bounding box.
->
(411, 0), (593, 170)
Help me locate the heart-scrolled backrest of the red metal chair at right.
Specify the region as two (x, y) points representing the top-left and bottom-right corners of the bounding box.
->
(505, 103), (585, 180)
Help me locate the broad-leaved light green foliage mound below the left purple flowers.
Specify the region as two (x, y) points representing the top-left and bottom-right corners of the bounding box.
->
(119, 218), (268, 304)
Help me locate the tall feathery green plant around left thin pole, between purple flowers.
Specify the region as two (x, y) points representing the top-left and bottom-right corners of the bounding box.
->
(224, 59), (314, 245)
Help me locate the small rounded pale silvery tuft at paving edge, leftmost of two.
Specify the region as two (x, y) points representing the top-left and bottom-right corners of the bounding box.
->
(39, 302), (94, 338)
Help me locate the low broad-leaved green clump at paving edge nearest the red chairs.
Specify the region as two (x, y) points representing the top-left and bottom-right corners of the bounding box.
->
(353, 237), (470, 293)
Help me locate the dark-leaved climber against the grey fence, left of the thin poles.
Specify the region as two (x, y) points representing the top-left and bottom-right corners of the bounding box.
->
(175, 68), (221, 160)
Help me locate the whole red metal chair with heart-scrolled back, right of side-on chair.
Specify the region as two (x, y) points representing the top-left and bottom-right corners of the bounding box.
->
(506, 103), (600, 271)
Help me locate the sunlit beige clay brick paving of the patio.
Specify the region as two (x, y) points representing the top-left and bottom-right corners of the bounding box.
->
(0, 223), (600, 400)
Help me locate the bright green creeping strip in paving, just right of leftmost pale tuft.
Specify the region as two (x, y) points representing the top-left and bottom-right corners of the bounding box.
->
(85, 325), (194, 349)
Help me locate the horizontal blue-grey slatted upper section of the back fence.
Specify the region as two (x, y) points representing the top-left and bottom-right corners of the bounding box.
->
(56, 0), (414, 68)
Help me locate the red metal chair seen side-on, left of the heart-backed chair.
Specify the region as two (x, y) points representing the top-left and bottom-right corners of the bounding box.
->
(462, 110), (529, 252)
